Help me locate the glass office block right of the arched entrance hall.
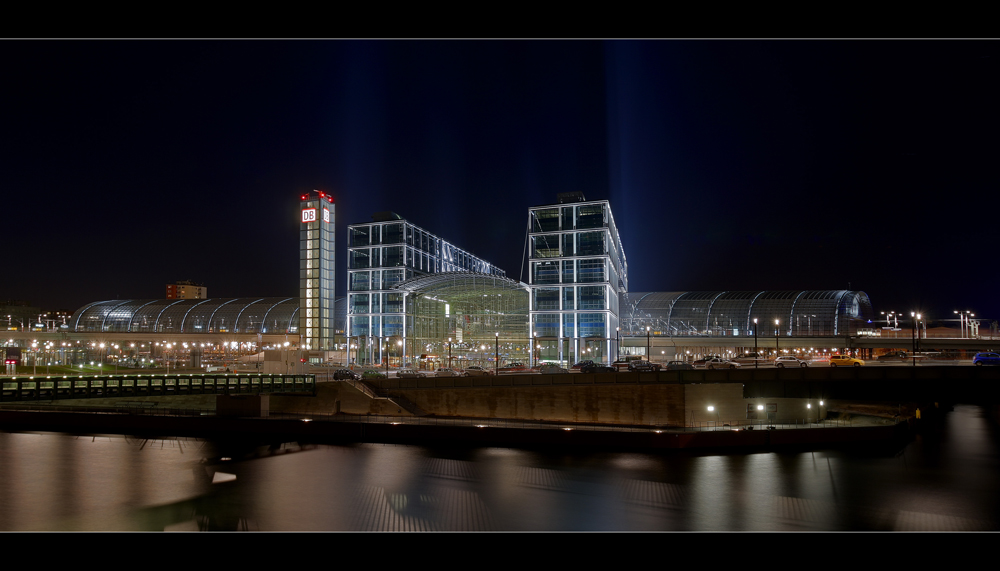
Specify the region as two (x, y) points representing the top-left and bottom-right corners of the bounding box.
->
(528, 193), (628, 363)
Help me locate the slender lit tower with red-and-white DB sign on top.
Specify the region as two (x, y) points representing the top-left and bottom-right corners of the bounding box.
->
(299, 190), (334, 351)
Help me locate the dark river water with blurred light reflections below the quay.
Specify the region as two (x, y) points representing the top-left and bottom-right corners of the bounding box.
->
(0, 406), (1000, 531)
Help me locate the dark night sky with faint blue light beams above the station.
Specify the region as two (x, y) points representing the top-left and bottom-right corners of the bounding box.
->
(0, 40), (1000, 319)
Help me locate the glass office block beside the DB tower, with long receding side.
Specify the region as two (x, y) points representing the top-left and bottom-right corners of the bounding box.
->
(347, 212), (505, 362)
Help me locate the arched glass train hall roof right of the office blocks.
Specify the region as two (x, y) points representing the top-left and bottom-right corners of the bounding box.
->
(621, 290), (875, 336)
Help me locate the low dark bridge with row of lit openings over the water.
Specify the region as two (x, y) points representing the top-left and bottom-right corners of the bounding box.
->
(0, 374), (316, 402)
